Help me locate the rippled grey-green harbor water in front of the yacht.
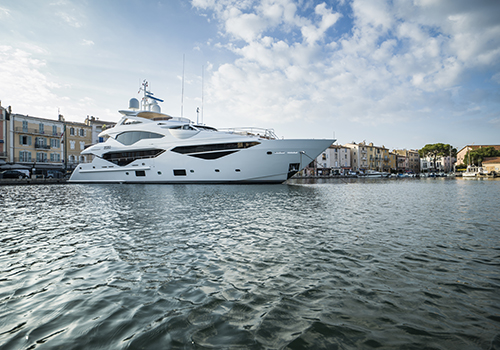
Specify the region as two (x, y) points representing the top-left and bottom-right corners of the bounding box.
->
(0, 178), (500, 350)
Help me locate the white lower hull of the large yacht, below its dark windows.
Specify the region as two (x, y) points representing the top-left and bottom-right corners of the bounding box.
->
(69, 138), (334, 184)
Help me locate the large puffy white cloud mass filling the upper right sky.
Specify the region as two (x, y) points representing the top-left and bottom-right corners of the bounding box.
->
(192, 0), (500, 131)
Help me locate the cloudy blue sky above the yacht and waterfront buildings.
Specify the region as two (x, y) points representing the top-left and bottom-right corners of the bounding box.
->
(0, 0), (500, 149)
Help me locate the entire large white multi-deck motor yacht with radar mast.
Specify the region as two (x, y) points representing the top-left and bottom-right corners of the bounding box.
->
(69, 82), (335, 183)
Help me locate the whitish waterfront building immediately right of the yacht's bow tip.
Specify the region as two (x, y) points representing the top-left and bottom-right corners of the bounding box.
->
(314, 145), (351, 176)
